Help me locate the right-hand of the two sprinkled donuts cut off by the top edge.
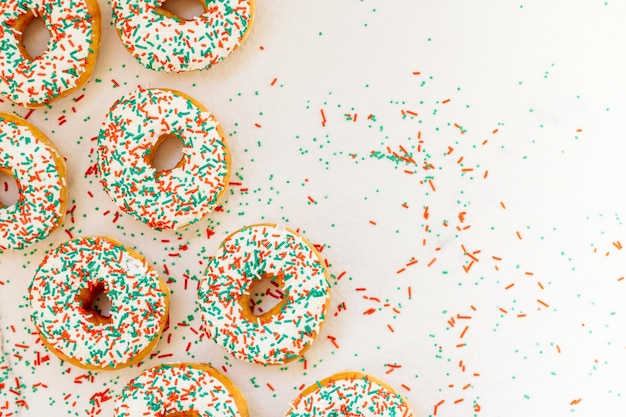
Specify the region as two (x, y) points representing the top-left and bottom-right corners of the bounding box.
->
(112, 0), (254, 72)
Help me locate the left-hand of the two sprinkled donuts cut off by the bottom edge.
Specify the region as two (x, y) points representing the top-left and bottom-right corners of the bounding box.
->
(113, 363), (248, 417)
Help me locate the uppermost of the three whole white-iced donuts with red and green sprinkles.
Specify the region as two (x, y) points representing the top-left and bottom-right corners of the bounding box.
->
(98, 88), (230, 230)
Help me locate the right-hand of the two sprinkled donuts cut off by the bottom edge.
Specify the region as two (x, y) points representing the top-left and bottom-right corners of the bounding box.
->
(286, 371), (413, 417)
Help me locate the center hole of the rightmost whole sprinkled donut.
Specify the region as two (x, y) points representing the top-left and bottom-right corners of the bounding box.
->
(242, 274), (286, 321)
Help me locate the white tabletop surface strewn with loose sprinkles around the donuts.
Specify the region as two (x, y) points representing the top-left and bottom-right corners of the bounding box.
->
(0, 0), (626, 417)
